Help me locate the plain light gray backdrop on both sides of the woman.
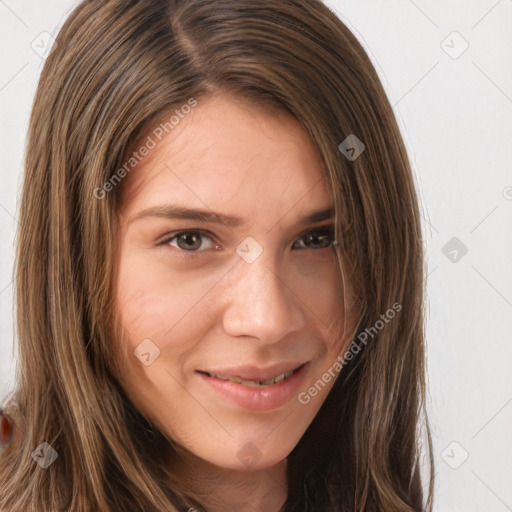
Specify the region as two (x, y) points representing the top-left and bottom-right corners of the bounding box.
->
(0, 0), (512, 512)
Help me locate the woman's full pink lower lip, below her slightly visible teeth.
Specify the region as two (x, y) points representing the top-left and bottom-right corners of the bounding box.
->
(198, 363), (310, 411)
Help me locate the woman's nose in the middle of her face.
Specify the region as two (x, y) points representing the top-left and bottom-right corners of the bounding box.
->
(223, 251), (306, 343)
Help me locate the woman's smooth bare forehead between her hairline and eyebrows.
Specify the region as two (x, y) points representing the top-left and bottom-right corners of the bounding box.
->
(118, 94), (329, 219)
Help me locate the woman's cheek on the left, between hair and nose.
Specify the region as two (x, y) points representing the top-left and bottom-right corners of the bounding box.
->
(112, 253), (224, 382)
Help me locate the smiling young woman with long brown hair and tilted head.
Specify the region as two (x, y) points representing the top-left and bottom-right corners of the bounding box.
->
(0, 0), (433, 512)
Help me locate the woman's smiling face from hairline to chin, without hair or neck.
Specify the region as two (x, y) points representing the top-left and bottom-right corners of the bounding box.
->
(116, 95), (350, 470)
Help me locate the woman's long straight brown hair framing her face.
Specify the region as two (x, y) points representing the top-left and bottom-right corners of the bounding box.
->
(0, 0), (434, 512)
